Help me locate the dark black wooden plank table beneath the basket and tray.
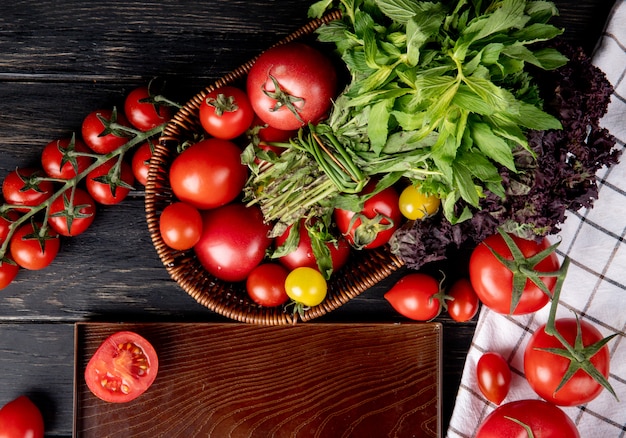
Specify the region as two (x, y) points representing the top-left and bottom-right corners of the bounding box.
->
(0, 0), (613, 436)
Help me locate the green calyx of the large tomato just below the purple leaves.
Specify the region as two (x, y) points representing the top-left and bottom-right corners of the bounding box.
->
(484, 228), (560, 314)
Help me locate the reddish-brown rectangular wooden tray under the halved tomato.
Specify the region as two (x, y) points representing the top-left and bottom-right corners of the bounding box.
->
(74, 323), (442, 438)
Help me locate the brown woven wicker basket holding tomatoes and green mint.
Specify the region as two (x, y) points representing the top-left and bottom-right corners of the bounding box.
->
(145, 12), (403, 325)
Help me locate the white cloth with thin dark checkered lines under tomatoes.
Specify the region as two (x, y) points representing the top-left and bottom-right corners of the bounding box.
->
(447, 0), (626, 438)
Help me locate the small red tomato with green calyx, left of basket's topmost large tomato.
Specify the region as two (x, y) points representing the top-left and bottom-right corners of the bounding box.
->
(200, 85), (254, 140)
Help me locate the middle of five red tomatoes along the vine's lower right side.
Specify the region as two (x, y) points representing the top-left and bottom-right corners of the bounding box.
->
(48, 187), (96, 236)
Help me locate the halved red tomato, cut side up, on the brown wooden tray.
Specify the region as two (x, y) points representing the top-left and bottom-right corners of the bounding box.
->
(85, 331), (159, 403)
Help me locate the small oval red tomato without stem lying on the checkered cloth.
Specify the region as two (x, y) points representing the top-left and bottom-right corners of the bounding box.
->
(476, 352), (511, 405)
